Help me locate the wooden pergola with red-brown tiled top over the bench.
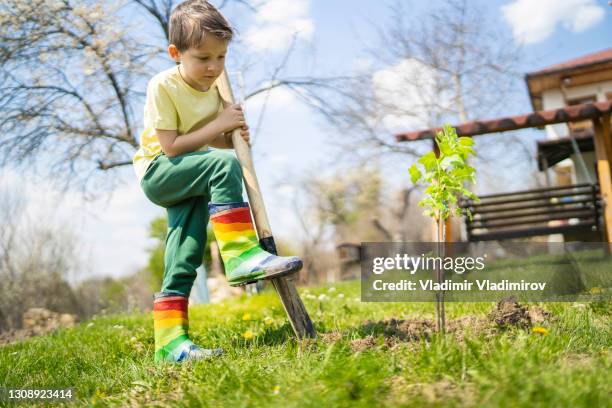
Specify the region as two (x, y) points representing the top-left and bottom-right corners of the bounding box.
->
(395, 101), (612, 242)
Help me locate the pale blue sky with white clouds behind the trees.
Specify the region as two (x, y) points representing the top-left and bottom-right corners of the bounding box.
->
(0, 0), (612, 280)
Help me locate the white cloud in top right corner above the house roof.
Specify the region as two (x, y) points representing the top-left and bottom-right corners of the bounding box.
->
(502, 0), (605, 44)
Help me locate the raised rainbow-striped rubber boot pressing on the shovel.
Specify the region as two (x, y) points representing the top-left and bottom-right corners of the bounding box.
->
(208, 202), (302, 286)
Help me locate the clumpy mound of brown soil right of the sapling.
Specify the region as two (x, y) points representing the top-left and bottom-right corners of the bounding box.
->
(488, 298), (554, 329)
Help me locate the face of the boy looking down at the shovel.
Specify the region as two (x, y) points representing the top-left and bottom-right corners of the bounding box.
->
(168, 34), (227, 91)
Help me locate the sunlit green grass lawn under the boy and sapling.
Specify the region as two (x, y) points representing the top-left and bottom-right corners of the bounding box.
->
(0, 282), (612, 408)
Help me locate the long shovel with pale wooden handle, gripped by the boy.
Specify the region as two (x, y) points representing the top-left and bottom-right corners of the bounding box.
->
(217, 71), (317, 339)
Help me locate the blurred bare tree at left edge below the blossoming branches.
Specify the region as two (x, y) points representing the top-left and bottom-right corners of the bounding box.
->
(0, 186), (85, 332)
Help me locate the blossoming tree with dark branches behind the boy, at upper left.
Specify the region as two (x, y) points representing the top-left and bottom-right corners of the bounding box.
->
(0, 0), (330, 197)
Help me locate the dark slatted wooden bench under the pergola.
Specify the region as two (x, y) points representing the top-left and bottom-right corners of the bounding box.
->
(460, 184), (604, 242)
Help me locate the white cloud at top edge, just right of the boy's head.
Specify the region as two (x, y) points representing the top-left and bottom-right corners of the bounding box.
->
(244, 0), (314, 51)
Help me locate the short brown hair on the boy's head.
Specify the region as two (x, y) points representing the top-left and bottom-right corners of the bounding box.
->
(168, 0), (234, 52)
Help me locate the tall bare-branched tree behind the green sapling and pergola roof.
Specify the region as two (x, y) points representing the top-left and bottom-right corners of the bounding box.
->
(284, 0), (536, 193)
